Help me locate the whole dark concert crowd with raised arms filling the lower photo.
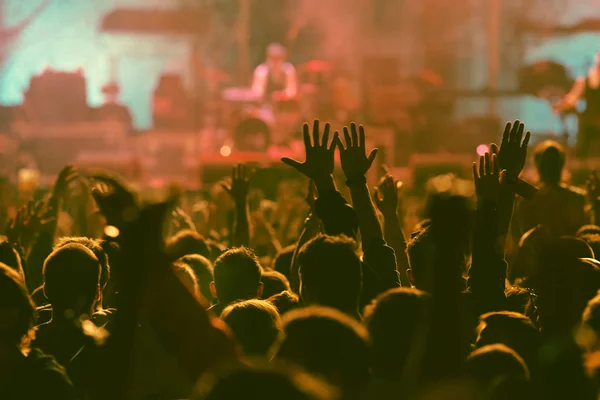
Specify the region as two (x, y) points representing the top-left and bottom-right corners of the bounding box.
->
(0, 121), (600, 400)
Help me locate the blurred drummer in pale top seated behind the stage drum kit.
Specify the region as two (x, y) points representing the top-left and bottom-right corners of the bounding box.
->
(252, 43), (298, 104)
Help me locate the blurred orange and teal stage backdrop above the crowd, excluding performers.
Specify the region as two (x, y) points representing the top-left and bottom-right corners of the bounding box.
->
(0, 0), (600, 189)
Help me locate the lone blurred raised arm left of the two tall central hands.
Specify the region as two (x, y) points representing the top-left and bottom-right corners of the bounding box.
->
(222, 164), (252, 247)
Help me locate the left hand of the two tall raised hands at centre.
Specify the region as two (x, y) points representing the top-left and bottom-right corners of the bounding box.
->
(281, 119), (338, 181)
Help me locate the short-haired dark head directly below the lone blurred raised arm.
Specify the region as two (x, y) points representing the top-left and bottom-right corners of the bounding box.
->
(213, 247), (262, 303)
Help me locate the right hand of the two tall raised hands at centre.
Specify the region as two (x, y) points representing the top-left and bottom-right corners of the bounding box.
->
(334, 122), (377, 180)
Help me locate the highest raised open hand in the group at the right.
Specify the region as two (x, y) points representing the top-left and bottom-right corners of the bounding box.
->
(492, 120), (531, 179)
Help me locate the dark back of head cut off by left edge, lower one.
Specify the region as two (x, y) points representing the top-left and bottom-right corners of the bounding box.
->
(0, 263), (37, 346)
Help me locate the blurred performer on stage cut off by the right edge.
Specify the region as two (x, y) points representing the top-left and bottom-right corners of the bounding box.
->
(553, 53), (600, 157)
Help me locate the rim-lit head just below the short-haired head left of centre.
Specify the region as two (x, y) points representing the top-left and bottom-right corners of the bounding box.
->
(221, 299), (282, 356)
